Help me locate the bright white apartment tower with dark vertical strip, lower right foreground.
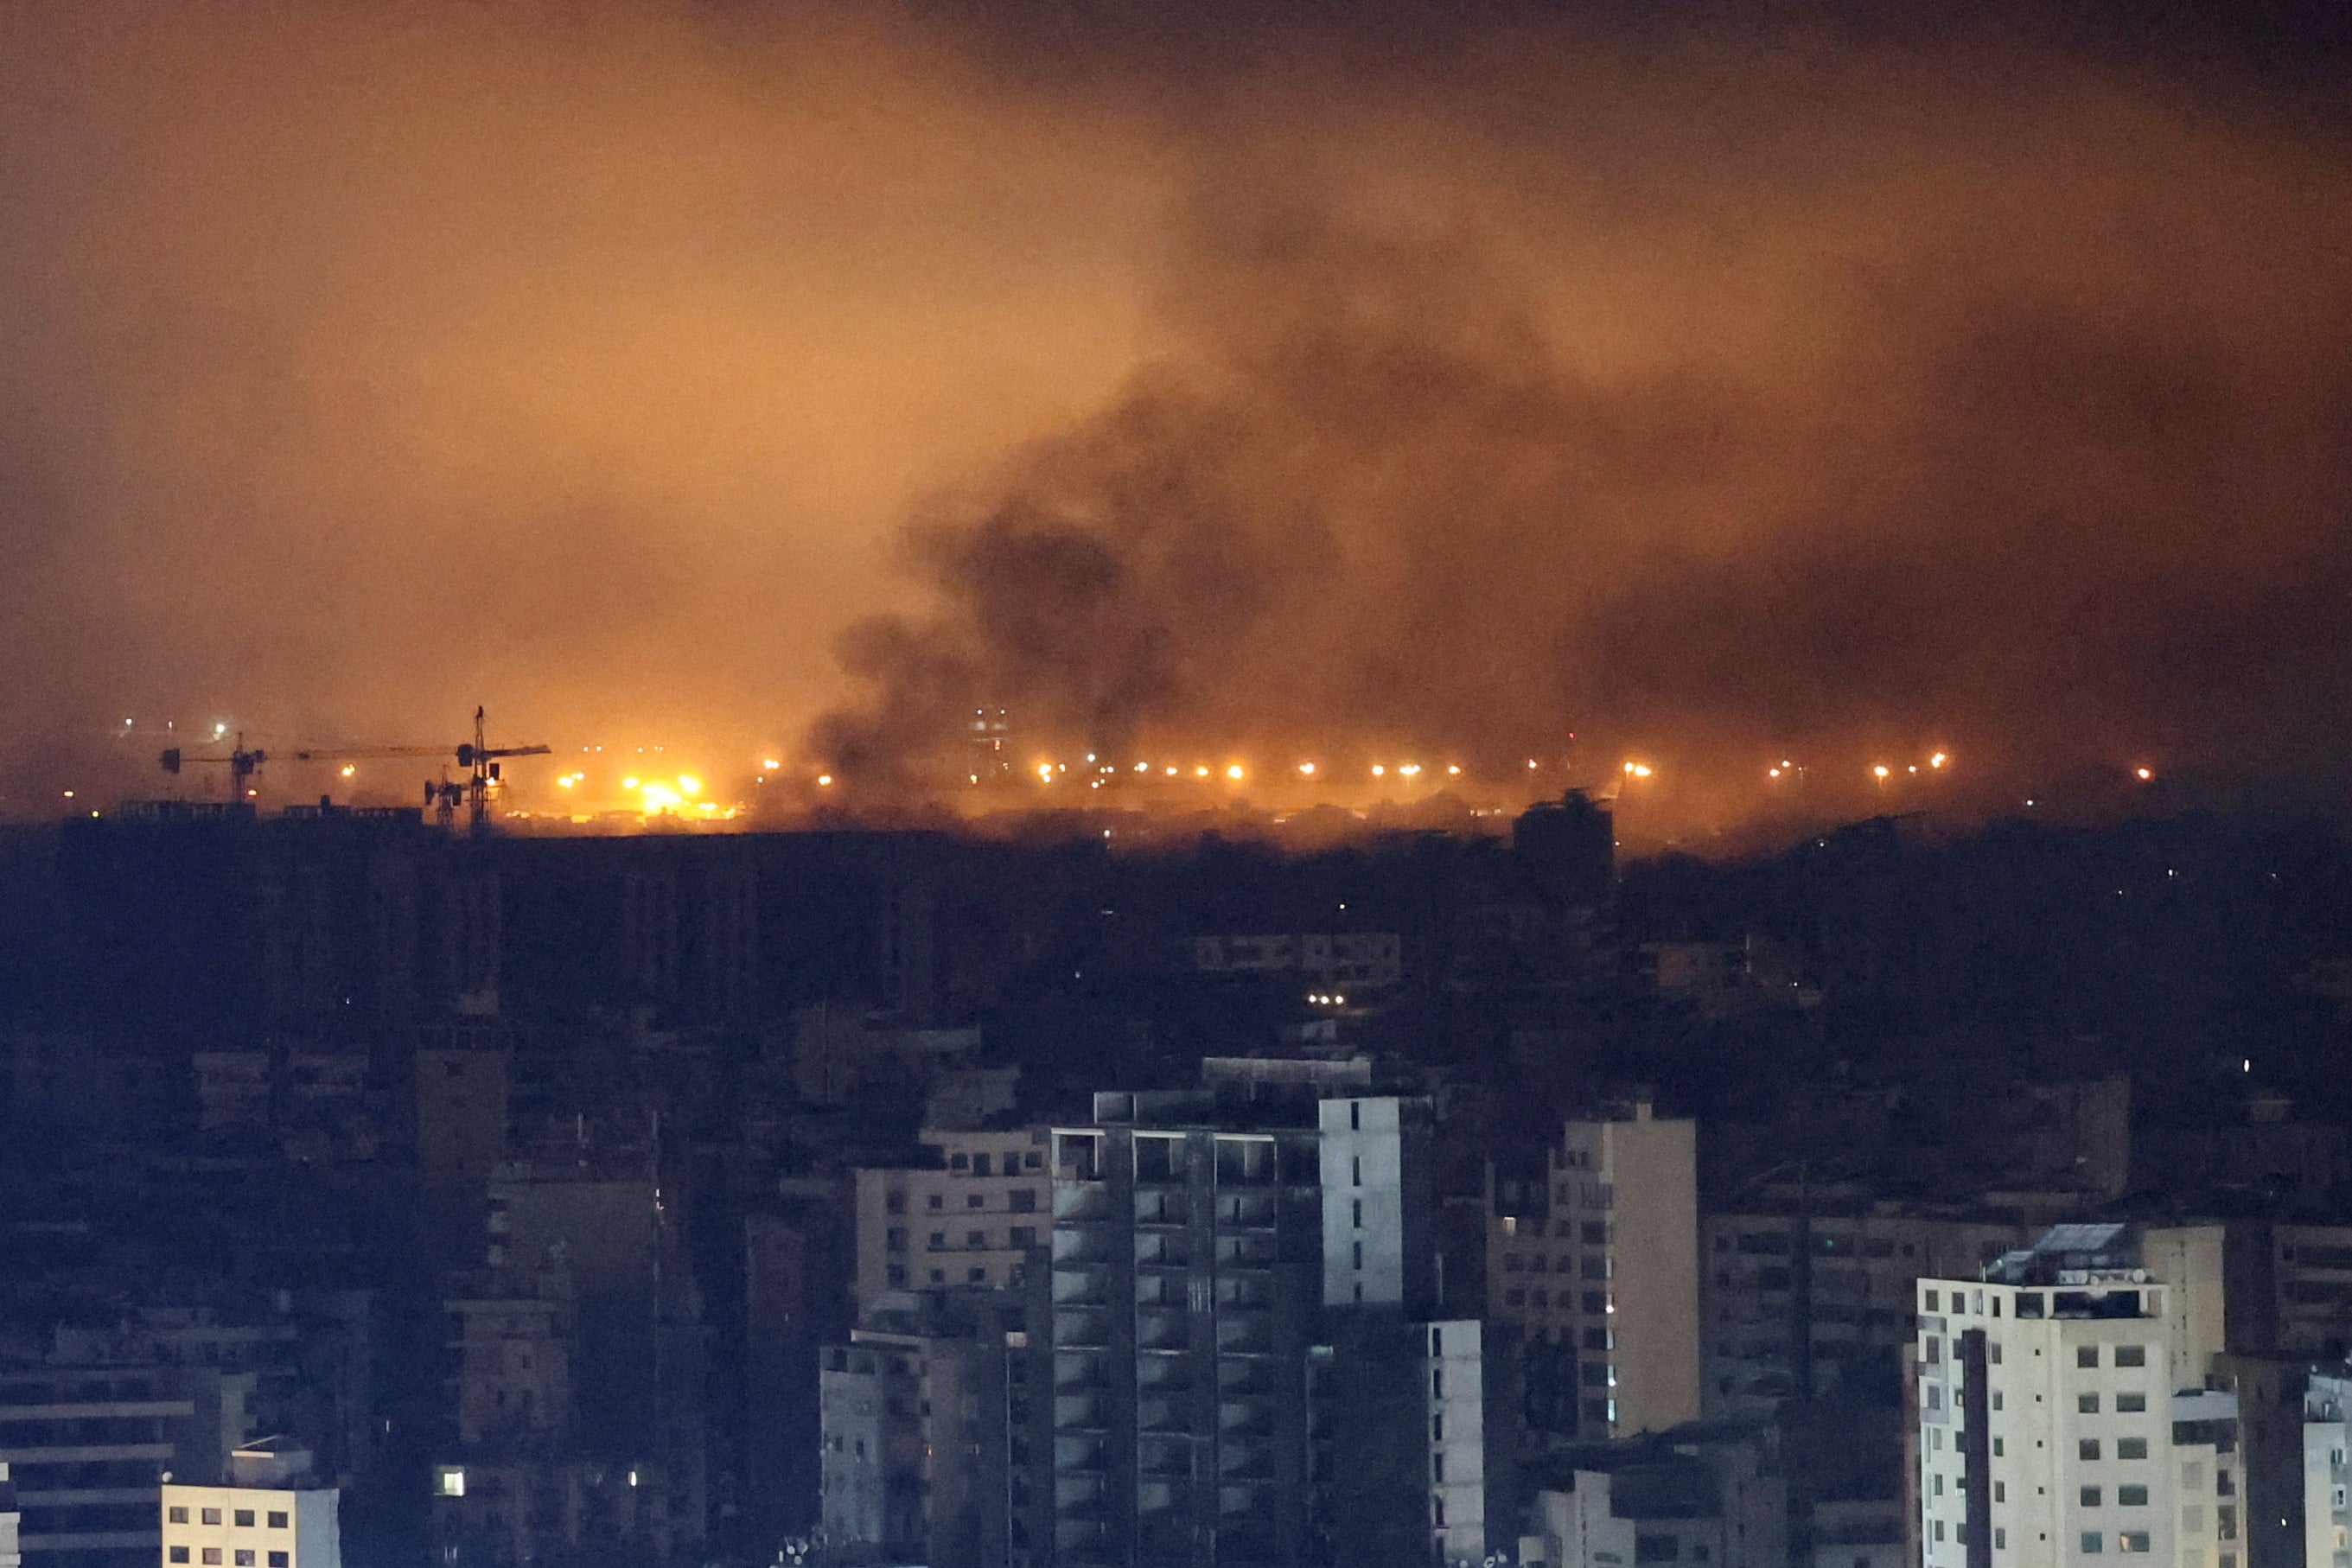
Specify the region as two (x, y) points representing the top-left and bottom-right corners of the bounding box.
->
(1915, 1225), (2241, 1568)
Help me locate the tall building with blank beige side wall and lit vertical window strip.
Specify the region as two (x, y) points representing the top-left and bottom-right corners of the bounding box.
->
(1487, 1100), (1700, 1437)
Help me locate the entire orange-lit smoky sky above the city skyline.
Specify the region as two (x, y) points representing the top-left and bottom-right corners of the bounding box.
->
(0, 4), (2352, 832)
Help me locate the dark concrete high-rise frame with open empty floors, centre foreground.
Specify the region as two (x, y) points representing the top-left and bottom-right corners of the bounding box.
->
(1044, 1093), (1324, 1568)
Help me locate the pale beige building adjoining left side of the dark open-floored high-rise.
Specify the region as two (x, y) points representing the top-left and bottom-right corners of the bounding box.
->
(856, 1128), (1051, 1314)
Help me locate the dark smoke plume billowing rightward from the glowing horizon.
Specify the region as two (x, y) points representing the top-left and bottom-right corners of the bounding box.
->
(819, 34), (2352, 818)
